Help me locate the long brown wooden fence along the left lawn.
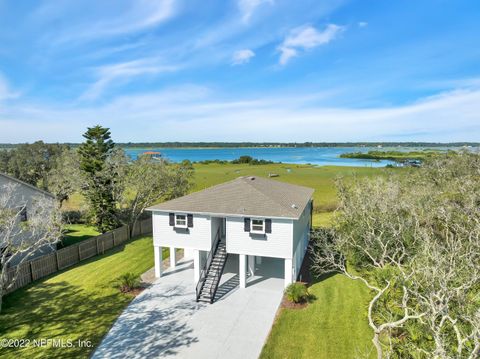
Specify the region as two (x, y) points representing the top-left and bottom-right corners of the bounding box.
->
(7, 218), (152, 293)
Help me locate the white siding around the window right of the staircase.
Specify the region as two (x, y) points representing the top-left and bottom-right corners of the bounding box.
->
(226, 217), (293, 258)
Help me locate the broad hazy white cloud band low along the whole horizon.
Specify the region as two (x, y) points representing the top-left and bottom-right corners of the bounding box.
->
(0, 85), (480, 143)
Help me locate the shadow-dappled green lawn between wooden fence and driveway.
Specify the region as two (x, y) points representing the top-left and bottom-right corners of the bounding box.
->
(0, 237), (161, 358)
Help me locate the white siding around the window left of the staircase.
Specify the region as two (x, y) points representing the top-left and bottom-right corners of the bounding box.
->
(152, 212), (212, 251)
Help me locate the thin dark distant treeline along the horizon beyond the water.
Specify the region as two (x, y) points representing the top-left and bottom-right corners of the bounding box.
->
(0, 142), (480, 148)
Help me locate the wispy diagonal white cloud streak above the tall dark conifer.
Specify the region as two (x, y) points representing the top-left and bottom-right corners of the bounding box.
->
(80, 59), (179, 100)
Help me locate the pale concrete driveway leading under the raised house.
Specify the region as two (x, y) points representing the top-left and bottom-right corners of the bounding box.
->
(93, 255), (284, 359)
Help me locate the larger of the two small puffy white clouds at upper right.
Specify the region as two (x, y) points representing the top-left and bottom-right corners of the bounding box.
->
(278, 24), (345, 65)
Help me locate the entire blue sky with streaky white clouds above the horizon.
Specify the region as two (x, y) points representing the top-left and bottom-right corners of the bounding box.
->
(0, 0), (480, 142)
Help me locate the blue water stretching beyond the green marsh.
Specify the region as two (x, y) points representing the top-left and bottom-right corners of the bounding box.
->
(125, 147), (402, 167)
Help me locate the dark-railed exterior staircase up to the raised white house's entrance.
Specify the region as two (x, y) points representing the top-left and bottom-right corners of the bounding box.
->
(197, 240), (228, 303)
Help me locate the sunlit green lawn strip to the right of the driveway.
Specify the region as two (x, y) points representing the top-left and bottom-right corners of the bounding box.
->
(260, 274), (373, 359)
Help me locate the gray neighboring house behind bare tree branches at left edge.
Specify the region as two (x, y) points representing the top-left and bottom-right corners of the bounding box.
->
(0, 173), (55, 265)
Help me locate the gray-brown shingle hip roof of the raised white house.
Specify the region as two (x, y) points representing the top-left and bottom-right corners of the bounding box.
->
(147, 176), (313, 219)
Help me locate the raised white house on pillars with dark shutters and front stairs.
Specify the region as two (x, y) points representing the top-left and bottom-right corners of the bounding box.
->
(148, 176), (313, 302)
